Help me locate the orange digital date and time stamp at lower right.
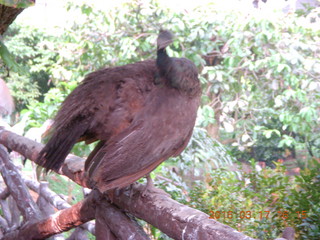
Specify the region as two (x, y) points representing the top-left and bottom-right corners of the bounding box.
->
(209, 210), (307, 220)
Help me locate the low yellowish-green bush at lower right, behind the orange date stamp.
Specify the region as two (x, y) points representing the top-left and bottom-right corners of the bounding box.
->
(180, 161), (320, 239)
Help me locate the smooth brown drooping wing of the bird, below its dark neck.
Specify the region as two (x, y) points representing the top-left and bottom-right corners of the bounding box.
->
(88, 88), (198, 192)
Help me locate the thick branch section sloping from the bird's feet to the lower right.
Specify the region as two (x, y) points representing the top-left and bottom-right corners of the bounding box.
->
(113, 184), (252, 240)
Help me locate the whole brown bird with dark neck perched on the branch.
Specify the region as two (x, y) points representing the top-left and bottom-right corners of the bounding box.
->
(38, 30), (201, 192)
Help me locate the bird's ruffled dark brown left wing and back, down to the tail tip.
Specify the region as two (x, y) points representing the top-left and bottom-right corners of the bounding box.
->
(38, 61), (155, 170)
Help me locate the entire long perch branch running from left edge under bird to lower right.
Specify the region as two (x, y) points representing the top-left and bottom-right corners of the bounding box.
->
(0, 130), (252, 240)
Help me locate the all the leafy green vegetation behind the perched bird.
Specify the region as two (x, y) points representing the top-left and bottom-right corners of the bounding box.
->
(0, 1), (320, 239)
